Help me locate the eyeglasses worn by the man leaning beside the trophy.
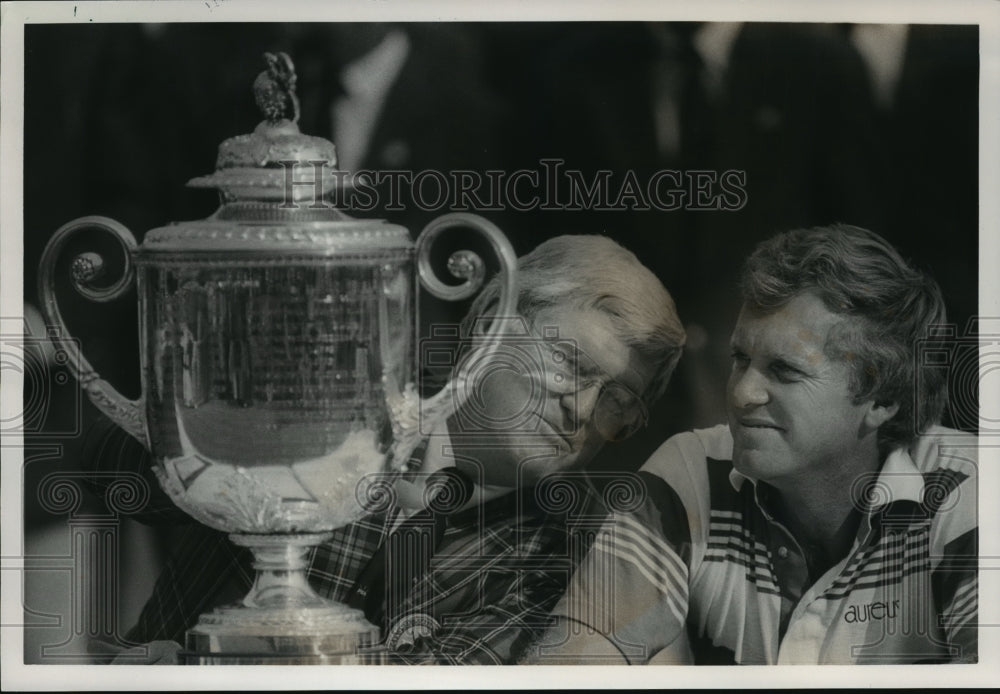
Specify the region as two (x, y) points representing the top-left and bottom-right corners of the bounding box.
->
(536, 338), (649, 441)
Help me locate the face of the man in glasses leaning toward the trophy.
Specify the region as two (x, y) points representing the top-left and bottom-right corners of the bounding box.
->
(451, 308), (654, 487)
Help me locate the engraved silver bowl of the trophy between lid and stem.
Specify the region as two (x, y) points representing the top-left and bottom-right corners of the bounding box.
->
(143, 261), (413, 532)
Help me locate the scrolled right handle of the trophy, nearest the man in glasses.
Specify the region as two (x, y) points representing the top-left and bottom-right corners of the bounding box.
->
(417, 212), (517, 420)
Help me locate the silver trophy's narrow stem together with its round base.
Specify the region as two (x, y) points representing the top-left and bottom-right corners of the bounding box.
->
(178, 533), (383, 665)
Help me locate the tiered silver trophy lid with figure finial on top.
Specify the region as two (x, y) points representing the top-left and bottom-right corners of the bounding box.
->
(141, 53), (412, 254)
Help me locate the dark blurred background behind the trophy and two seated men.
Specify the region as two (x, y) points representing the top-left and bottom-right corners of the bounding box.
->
(24, 23), (979, 658)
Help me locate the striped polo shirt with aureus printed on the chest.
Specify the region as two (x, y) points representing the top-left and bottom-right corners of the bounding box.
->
(540, 426), (977, 664)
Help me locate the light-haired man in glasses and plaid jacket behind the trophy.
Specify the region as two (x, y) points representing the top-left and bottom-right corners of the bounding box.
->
(109, 236), (684, 664)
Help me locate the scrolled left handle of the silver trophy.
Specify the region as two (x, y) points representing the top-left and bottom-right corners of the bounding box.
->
(38, 216), (149, 448)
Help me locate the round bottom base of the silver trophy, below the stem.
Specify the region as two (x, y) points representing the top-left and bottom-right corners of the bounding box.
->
(177, 603), (384, 665)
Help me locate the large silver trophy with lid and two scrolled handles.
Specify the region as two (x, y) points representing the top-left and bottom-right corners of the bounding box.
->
(39, 54), (516, 664)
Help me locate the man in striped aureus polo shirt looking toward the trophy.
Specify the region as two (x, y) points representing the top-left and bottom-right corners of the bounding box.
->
(531, 225), (977, 664)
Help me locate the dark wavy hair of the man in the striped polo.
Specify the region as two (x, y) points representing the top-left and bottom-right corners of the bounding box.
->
(741, 224), (947, 452)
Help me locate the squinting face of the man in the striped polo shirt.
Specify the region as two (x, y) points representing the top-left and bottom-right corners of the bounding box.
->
(728, 292), (870, 489)
